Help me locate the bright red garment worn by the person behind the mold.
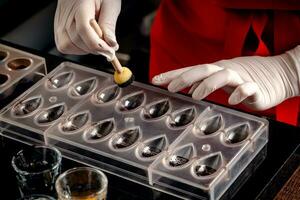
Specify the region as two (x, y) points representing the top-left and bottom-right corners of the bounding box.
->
(149, 0), (300, 125)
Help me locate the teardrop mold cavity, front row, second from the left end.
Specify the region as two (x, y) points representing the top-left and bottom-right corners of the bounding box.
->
(37, 105), (65, 124)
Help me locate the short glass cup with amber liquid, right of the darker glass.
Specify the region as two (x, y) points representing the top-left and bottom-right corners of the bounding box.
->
(55, 167), (108, 200)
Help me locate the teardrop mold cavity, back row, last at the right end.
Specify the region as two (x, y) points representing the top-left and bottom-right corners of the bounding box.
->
(225, 123), (250, 144)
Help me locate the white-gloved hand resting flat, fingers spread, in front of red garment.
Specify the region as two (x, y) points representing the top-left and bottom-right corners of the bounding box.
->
(152, 45), (300, 110)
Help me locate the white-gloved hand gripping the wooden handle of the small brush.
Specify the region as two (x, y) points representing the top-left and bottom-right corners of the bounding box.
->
(54, 0), (121, 60)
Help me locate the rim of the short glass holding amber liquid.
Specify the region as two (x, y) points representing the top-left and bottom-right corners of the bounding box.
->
(55, 167), (108, 197)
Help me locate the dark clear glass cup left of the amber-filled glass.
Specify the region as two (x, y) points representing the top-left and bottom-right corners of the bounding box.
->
(12, 146), (62, 197)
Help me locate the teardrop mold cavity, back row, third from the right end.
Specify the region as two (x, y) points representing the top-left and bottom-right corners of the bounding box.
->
(170, 108), (196, 127)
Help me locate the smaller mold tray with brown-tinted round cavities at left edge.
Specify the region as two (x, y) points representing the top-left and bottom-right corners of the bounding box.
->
(0, 44), (47, 104)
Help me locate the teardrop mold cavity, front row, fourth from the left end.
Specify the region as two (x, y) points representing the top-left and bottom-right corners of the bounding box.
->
(85, 120), (115, 140)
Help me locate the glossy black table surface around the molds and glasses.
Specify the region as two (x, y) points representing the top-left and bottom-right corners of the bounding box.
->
(0, 41), (300, 200)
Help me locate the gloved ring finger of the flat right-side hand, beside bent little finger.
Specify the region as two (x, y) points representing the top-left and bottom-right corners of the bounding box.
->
(192, 69), (244, 100)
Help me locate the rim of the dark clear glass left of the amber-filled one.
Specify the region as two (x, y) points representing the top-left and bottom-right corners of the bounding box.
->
(11, 145), (62, 175)
